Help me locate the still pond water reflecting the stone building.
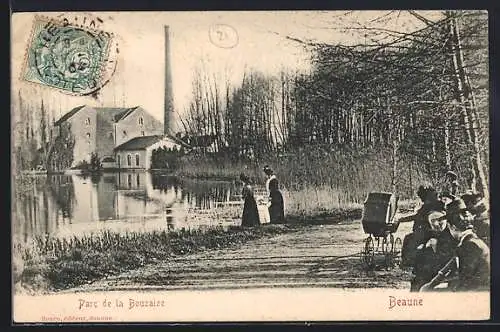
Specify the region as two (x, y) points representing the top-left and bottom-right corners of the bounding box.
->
(13, 172), (240, 241)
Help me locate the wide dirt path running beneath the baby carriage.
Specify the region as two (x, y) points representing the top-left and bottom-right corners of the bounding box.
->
(68, 221), (411, 292)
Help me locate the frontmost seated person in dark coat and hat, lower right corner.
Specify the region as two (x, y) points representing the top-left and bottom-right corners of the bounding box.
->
(446, 198), (490, 291)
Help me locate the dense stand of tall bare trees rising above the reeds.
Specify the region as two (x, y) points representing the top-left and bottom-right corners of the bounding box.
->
(178, 11), (489, 197)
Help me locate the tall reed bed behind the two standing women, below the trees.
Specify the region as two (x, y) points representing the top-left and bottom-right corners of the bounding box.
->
(176, 147), (428, 201)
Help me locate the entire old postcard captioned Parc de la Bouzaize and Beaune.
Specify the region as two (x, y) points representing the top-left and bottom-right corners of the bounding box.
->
(11, 10), (490, 324)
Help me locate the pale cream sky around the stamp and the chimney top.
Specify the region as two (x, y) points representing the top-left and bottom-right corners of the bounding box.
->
(11, 11), (441, 130)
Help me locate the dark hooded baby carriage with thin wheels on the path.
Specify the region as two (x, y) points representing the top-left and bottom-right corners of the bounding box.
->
(361, 192), (402, 268)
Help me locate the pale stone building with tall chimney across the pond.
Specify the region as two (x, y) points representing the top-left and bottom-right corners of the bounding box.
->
(51, 26), (182, 169)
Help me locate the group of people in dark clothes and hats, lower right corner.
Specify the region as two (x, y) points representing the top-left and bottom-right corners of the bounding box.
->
(402, 180), (490, 292)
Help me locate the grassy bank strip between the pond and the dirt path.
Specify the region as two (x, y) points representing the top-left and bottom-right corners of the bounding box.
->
(13, 224), (301, 292)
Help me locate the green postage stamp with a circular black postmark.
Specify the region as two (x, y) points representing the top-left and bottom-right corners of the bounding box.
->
(22, 17), (116, 96)
